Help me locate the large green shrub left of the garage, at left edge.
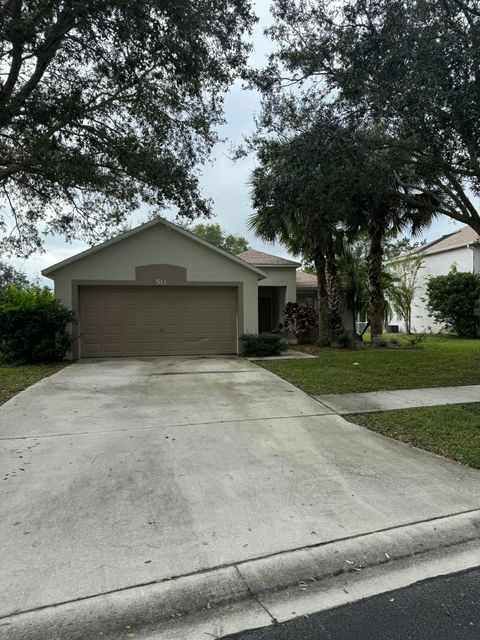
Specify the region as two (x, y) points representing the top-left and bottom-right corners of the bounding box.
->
(0, 285), (74, 364)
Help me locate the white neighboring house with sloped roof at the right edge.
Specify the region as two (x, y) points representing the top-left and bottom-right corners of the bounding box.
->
(391, 227), (480, 333)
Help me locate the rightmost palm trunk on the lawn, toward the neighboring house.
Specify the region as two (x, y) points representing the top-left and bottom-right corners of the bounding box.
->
(368, 223), (384, 340)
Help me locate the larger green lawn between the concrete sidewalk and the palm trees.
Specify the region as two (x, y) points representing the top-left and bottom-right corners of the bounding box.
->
(258, 336), (480, 395)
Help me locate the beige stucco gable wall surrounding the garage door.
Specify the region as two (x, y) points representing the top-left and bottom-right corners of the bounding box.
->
(42, 220), (266, 360)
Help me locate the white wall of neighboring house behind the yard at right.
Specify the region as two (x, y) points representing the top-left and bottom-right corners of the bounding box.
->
(390, 245), (480, 333)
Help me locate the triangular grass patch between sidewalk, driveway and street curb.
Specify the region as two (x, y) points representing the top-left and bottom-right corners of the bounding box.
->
(348, 403), (480, 469)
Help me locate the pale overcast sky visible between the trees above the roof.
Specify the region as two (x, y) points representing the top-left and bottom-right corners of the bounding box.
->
(12, 1), (462, 283)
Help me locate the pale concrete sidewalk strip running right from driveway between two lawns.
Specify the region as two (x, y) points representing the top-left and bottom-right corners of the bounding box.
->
(313, 385), (480, 415)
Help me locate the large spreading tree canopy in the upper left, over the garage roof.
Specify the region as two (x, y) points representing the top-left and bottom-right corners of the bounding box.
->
(0, 0), (255, 255)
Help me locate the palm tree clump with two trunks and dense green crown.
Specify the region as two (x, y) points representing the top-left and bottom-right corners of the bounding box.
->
(250, 110), (432, 344)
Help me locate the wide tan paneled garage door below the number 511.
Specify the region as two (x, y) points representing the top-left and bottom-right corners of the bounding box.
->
(79, 286), (237, 358)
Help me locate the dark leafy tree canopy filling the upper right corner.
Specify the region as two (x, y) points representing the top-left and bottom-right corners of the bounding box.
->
(256, 0), (480, 232)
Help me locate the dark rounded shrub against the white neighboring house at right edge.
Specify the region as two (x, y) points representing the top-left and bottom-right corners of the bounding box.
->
(427, 267), (480, 338)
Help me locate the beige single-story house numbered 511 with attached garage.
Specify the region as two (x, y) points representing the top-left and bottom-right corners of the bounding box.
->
(42, 219), (312, 358)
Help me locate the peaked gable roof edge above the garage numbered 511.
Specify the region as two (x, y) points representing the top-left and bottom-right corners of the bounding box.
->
(42, 218), (267, 280)
